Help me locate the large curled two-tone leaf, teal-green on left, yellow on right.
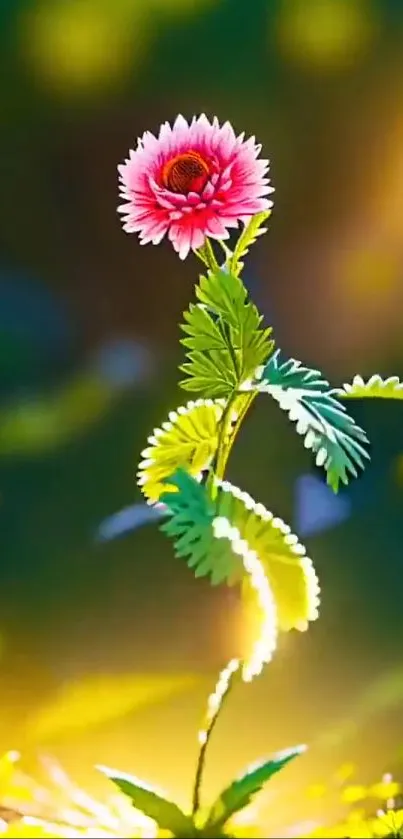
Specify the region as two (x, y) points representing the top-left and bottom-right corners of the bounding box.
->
(161, 471), (319, 631)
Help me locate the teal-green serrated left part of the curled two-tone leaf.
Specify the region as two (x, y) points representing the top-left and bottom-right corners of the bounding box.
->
(160, 469), (242, 585)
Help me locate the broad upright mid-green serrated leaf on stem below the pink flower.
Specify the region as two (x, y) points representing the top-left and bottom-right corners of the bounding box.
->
(180, 269), (273, 398)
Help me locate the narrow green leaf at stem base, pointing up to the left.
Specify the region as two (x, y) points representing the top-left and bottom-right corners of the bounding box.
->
(97, 766), (194, 837)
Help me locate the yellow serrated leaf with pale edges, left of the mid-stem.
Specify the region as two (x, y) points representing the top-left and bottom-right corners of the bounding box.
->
(138, 399), (225, 502)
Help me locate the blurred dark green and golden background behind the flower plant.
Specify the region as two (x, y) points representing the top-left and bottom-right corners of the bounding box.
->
(0, 0), (403, 832)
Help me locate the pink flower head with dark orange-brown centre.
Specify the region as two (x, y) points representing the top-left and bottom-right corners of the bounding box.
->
(118, 114), (273, 259)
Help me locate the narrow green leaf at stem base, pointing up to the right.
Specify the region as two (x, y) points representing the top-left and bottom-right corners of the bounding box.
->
(207, 746), (306, 829)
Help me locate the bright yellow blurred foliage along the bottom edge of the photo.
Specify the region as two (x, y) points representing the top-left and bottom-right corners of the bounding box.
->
(0, 752), (403, 839)
